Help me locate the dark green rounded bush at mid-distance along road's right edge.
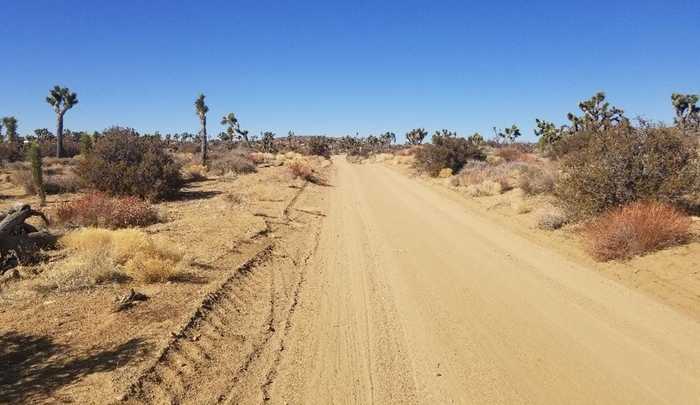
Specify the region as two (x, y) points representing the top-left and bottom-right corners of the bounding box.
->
(414, 134), (486, 177)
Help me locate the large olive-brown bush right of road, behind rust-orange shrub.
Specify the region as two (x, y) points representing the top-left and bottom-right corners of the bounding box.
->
(556, 128), (698, 217)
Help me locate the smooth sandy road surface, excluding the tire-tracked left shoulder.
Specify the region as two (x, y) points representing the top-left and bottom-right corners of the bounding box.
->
(265, 159), (700, 404)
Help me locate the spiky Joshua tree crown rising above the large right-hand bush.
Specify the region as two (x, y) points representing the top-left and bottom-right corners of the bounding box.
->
(566, 91), (629, 133)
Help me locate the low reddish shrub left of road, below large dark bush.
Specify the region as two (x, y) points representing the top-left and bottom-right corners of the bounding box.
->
(55, 193), (159, 229)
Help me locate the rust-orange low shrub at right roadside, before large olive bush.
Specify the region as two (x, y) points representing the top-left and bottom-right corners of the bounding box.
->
(584, 202), (691, 261)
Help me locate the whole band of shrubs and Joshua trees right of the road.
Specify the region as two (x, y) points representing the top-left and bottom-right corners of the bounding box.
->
(336, 92), (700, 261)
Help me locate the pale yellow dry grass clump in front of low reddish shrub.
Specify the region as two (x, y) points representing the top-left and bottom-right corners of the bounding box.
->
(36, 228), (183, 291)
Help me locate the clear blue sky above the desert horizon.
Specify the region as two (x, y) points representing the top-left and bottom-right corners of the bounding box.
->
(0, 0), (700, 139)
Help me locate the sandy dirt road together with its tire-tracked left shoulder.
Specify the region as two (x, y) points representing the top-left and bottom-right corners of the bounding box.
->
(1, 158), (700, 404)
